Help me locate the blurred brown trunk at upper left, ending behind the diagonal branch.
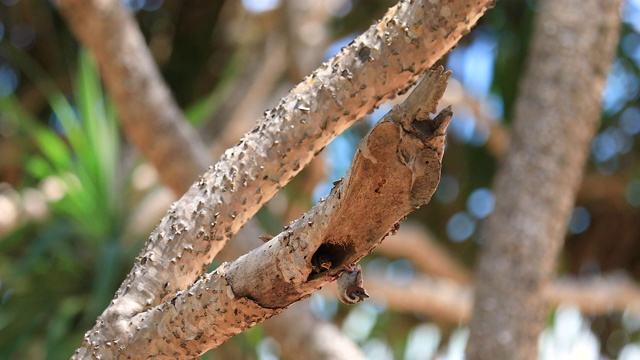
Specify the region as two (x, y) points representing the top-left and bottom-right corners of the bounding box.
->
(57, 0), (211, 195)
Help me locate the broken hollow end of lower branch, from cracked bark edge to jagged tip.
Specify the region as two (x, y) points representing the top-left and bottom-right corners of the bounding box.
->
(224, 67), (452, 309)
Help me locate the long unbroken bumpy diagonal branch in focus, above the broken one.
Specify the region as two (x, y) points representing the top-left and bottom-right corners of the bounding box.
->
(69, 0), (493, 355)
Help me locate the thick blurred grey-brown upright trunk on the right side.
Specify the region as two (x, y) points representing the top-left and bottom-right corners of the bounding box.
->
(467, 0), (620, 359)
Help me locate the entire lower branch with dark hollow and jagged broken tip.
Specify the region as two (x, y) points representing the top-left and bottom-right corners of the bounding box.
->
(76, 68), (451, 358)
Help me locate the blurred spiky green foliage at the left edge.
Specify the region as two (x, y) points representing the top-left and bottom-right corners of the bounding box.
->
(0, 50), (132, 359)
